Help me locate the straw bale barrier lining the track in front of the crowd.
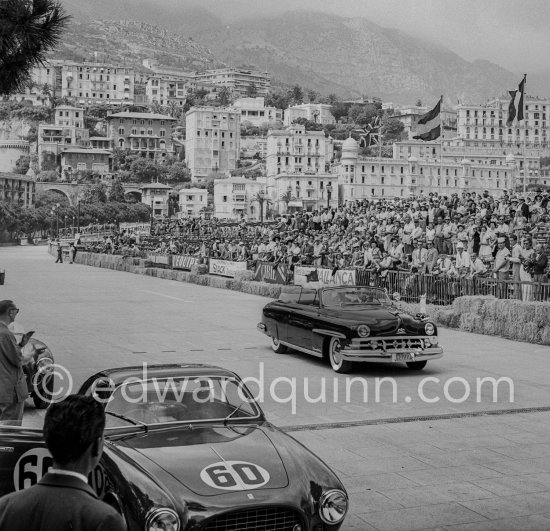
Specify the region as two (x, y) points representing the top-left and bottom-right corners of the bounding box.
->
(62, 247), (550, 345)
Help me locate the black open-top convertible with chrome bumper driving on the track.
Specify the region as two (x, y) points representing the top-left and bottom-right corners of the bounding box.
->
(258, 286), (443, 373)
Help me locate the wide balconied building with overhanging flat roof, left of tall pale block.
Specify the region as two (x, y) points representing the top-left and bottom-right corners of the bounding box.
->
(107, 111), (176, 160)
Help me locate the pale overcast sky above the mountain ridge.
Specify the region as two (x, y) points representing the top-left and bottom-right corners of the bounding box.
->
(203, 0), (550, 73)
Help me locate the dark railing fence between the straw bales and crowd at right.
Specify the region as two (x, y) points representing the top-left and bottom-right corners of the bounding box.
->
(357, 270), (550, 306)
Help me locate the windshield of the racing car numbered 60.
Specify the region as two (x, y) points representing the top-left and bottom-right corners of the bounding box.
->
(105, 376), (260, 427)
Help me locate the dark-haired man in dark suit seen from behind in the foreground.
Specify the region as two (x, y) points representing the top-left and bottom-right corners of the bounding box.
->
(0, 395), (126, 531)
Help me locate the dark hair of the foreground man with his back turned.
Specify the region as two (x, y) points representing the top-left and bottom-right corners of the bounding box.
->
(44, 395), (105, 465)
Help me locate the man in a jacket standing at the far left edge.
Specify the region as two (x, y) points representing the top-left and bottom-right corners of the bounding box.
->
(0, 300), (29, 426)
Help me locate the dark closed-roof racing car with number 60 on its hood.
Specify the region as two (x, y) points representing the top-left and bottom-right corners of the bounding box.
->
(0, 365), (348, 531)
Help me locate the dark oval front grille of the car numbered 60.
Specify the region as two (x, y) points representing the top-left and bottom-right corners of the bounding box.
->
(202, 507), (303, 531)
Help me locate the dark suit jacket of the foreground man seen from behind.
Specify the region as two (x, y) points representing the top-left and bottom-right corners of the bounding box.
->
(0, 473), (126, 531)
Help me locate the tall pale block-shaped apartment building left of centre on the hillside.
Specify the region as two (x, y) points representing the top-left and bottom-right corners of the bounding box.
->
(185, 106), (241, 182)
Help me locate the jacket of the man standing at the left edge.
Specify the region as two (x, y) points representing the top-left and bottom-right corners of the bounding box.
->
(0, 323), (28, 406)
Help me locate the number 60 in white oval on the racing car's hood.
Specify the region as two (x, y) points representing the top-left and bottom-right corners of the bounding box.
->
(201, 461), (270, 490)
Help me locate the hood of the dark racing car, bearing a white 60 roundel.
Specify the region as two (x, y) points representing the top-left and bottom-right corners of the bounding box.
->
(115, 425), (288, 496)
